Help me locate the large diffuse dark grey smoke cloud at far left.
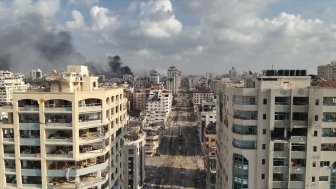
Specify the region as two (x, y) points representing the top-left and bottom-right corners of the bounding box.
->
(0, 13), (85, 73)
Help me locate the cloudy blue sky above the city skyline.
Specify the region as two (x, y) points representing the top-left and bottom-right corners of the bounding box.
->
(0, 0), (336, 74)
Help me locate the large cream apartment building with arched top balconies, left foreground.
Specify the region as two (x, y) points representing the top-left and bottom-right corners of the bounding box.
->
(0, 65), (128, 189)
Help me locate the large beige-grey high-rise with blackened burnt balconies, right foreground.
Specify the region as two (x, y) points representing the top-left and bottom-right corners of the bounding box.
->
(216, 70), (336, 189)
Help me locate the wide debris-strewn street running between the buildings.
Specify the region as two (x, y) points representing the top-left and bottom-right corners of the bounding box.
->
(144, 94), (205, 189)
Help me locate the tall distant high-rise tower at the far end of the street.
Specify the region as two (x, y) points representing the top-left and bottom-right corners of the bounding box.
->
(166, 66), (182, 96)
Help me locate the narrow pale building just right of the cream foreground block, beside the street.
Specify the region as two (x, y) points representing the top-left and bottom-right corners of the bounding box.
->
(123, 129), (146, 189)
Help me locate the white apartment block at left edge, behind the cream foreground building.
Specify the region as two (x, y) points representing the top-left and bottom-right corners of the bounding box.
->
(0, 71), (28, 104)
